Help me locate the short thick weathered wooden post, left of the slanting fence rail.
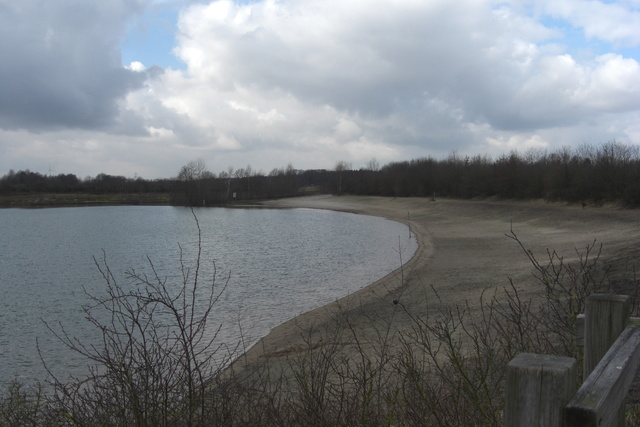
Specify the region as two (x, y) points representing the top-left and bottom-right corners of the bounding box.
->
(504, 353), (576, 427)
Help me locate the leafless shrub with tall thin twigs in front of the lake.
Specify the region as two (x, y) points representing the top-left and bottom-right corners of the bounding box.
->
(43, 215), (228, 426)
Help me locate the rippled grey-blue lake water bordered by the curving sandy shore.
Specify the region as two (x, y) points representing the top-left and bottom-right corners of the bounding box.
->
(0, 206), (417, 390)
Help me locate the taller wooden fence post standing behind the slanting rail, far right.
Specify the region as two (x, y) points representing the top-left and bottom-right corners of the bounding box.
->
(583, 294), (631, 426)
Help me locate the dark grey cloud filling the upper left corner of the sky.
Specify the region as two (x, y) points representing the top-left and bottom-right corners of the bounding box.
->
(0, 0), (154, 131)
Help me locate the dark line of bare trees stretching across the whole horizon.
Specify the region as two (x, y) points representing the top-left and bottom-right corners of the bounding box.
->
(0, 141), (640, 207)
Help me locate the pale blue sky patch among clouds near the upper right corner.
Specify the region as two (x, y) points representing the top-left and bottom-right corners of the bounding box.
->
(541, 16), (640, 62)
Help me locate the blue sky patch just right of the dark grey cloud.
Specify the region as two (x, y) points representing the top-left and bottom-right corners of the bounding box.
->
(120, 8), (186, 70)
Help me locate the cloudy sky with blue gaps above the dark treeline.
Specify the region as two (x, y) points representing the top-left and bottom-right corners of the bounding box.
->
(0, 0), (640, 179)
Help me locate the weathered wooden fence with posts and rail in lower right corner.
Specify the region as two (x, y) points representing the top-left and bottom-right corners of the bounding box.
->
(504, 295), (640, 427)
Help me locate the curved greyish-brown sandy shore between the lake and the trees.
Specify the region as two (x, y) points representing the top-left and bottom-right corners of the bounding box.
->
(229, 196), (640, 380)
